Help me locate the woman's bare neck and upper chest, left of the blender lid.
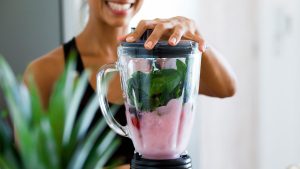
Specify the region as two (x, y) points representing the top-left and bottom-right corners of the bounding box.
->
(76, 16), (127, 57)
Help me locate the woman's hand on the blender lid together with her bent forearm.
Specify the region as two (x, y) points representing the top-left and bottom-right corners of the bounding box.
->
(120, 16), (236, 98)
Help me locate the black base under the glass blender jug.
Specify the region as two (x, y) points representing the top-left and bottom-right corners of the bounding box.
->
(130, 153), (192, 169)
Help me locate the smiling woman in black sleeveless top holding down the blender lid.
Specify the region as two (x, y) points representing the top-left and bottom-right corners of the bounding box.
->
(24, 0), (235, 167)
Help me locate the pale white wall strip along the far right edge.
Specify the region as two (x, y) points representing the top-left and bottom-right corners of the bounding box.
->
(258, 0), (300, 169)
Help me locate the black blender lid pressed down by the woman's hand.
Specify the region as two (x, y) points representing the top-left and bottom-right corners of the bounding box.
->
(120, 29), (198, 58)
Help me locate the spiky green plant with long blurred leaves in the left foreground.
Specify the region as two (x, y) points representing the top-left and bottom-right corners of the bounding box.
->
(0, 56), (120, 169)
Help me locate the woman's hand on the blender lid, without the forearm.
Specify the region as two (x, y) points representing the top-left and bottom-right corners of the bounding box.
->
(122, 16), (205, 52)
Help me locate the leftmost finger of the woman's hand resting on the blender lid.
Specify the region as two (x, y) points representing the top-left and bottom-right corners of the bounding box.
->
(126, 20), (157, 42)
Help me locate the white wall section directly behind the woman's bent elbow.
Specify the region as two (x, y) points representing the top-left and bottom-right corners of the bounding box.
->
(198, 0), (258, 169)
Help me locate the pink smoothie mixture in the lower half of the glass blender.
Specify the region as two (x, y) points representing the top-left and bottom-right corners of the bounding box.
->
(125, 99), (194, 159)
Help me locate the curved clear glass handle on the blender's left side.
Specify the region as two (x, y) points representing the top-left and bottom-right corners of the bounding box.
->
(97, 64), (129, 137)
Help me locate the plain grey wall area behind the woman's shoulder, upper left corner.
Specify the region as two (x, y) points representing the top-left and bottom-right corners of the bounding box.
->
(0, 0), (61, 74)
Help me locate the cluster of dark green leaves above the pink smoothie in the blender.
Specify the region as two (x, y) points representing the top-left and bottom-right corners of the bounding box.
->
(127, 59), (187, 111)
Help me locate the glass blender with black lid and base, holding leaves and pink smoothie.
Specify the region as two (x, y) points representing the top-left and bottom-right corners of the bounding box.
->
(97, 30), (201, 169)
